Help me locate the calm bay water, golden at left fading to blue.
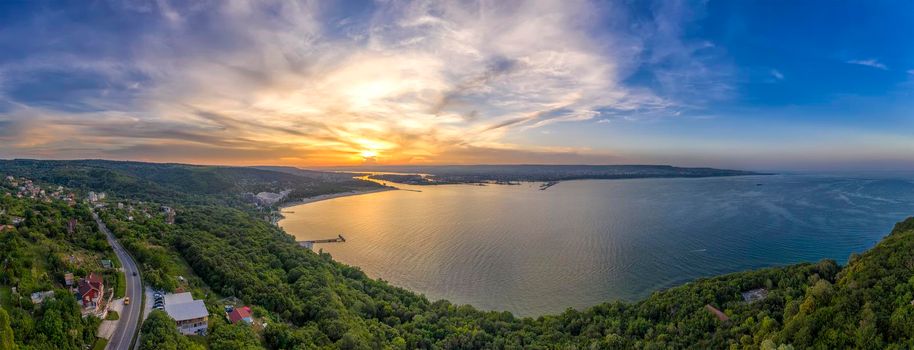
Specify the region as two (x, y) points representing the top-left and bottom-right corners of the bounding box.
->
(280, 175), (914, 316)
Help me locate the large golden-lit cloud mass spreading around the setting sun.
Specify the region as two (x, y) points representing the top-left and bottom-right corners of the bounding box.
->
(0, 0), (729, 165)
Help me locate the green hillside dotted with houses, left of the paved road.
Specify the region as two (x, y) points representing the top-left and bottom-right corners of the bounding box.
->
(0, 178), (122, 350)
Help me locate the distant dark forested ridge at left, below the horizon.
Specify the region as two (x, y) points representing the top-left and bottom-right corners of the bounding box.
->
(0, 159), (379, 205)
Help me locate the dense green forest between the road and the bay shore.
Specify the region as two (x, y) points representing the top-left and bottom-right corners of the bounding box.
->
(0, 162), (914, 349)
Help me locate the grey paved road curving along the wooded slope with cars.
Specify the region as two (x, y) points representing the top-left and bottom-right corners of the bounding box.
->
(92, 212), (143, 350)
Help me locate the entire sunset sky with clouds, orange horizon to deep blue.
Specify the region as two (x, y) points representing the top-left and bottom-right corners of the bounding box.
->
(0, 0), (914, 171)
